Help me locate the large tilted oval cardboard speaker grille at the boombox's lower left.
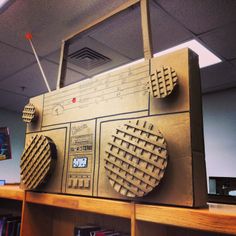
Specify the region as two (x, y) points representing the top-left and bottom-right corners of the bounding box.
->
(20, 135), (56, 190)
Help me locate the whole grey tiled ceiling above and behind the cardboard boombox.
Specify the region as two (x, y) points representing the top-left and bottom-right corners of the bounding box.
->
(0, 0), (236, 111)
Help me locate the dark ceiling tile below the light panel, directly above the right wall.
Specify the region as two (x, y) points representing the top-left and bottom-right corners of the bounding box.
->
(201, 62), (236, 92)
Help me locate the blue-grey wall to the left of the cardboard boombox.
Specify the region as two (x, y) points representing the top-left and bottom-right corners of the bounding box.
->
(0, 109), (25, 183)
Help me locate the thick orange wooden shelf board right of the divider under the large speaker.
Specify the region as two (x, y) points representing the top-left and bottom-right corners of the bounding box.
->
(135, 203), (236, 235)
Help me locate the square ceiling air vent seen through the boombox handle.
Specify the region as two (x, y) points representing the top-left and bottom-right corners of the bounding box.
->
(68, 47), (111, 71)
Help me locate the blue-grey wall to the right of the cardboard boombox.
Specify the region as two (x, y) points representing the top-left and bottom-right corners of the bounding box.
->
(203, 88), (236, 183)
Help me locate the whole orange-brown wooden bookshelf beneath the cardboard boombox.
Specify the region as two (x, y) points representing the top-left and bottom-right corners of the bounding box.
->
(0, 186), (236, 236)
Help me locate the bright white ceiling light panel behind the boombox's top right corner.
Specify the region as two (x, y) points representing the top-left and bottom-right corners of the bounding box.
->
(154, 39), (222, 68)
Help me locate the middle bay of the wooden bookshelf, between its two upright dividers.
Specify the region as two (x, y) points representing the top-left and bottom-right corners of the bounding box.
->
(22, 192), (135, 236)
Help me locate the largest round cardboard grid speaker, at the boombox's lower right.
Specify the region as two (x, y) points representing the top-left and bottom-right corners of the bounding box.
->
(105, 120), (167, 197)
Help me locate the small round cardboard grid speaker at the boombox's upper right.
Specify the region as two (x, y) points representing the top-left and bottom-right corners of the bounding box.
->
(149, 66), (178, 98)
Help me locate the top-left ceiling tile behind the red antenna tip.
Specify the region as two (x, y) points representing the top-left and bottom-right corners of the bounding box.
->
(0, 0), (125, 56)
